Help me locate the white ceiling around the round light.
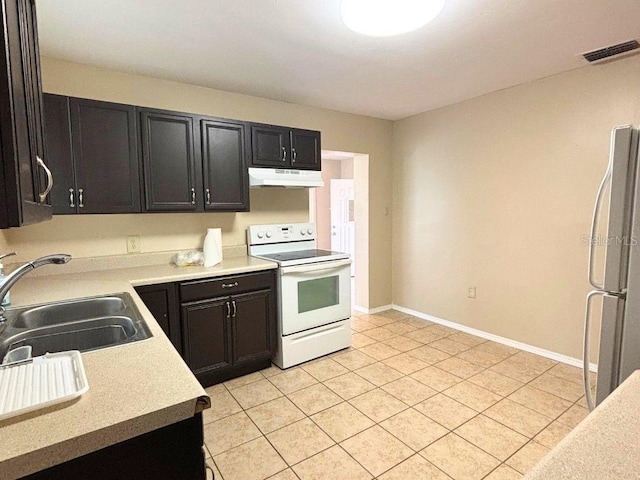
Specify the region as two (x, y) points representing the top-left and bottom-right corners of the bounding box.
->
(37, 0), (640, 120)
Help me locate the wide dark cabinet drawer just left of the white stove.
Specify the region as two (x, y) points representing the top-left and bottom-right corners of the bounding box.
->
(180, 270), (273, 303)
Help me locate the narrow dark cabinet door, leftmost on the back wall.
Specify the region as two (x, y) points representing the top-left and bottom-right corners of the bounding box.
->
(44, 93), (77, 215)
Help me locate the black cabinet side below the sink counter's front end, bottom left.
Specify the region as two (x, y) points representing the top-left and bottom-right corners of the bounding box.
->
(23, 413), (206, 480)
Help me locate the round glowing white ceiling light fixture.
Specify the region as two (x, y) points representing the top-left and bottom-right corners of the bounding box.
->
(342, 0), (445, 37)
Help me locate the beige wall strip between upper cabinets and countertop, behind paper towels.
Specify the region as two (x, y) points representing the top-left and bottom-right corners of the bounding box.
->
(5, 189), (309, 261)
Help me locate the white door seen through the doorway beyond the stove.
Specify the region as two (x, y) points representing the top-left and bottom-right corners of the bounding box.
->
(331, 179), (355, 277)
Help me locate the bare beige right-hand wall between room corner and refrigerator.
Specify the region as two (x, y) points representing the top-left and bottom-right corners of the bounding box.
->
(393, 56), (640, 357)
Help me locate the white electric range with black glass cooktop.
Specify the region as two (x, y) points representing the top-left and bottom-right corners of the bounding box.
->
(247, 223), (351, 368)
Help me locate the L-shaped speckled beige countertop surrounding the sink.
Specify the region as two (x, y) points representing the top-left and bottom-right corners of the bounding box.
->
(0, 255), (276, 479)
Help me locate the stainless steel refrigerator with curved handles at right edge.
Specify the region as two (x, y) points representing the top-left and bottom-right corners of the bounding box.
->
(584, 126), (640, 409)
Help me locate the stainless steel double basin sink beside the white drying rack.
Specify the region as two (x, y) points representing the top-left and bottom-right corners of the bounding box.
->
(0, 293), (152, 363)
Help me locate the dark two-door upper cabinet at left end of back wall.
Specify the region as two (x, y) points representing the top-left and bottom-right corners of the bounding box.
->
(45, 94), (141, 214)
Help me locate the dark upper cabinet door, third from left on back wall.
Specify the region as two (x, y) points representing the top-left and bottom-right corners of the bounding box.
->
(140, 110), (199, 212)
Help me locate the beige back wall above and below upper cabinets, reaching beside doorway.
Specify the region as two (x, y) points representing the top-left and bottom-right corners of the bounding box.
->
(0, 58), (392, 308)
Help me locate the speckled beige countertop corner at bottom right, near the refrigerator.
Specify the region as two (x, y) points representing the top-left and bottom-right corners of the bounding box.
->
(524, 370), (640, 480)
